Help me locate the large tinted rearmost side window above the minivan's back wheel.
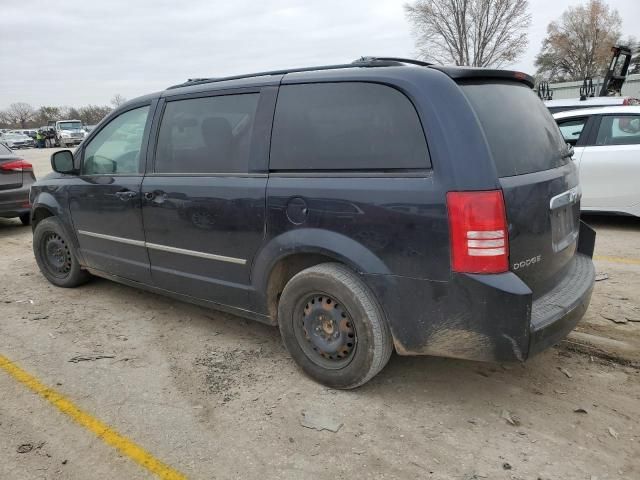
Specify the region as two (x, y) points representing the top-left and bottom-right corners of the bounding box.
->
(270, 83), (430, 170)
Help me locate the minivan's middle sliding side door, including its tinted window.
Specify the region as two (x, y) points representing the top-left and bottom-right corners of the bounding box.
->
(142, 89), (275, 308)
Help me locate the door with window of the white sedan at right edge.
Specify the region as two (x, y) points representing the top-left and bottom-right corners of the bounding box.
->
(580, 114), (640, 211)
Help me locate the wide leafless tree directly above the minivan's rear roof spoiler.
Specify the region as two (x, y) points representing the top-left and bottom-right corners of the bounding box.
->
(404, 0), (531, 68)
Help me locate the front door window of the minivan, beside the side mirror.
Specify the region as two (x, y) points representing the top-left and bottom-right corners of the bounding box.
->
(82, 107), (149, 175)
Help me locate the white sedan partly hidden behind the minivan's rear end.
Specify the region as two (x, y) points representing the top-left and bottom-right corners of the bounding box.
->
(553, 106), (640, 217)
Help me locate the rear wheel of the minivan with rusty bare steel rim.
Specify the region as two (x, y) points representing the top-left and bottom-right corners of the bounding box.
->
(278, 263), (393, 389)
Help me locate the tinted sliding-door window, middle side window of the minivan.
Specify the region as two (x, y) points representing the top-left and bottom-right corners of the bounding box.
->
(155, 93), (259, 173)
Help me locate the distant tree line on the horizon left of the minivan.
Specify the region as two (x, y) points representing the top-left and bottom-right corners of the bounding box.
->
(0, 94), (126, 129)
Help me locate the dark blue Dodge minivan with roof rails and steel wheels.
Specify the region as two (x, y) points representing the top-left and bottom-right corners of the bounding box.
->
(31, 58), (595, 388)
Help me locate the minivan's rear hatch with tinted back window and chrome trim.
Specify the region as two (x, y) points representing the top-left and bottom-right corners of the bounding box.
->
(461, 79), (580, 298)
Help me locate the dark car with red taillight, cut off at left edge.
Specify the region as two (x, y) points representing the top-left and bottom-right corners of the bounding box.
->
(0, 142), (36, 225)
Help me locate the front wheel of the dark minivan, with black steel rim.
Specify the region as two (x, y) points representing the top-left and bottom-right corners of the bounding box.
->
(33, 217), (91, 288)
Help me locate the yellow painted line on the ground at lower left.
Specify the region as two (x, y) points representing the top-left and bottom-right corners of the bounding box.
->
(0, 355), (187, 480)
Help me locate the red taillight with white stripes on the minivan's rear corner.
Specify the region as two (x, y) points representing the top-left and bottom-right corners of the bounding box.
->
(447, 190), (509, 273)
